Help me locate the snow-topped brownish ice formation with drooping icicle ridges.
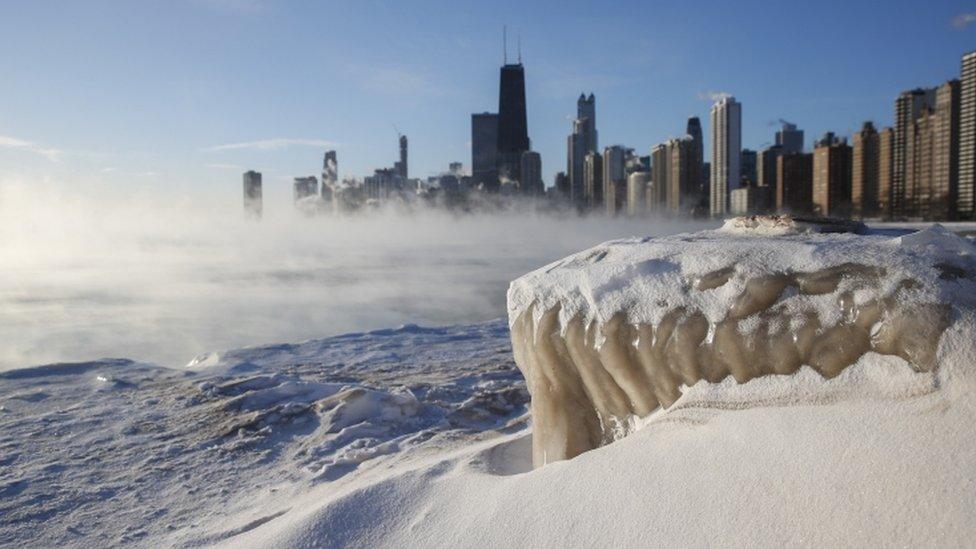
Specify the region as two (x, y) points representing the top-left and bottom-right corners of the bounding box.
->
(508, 223), (976, 467)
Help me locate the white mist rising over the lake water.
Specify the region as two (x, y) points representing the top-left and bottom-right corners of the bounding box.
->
(0, 181), (716, 369)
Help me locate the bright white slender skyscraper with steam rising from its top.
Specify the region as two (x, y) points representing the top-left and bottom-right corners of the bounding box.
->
(709, 97), (742, 217)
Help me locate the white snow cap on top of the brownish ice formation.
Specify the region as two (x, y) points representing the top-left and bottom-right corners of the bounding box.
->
(508, 222), (976, 326)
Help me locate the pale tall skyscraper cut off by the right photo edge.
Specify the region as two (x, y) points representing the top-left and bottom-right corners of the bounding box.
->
(956, 51), (976, 220)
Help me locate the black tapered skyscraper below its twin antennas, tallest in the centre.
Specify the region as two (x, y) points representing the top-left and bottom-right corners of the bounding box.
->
(498, 59), (532, 183)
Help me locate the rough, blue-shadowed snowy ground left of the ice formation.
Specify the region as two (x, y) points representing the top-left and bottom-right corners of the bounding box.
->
(0, 321), (528, 547)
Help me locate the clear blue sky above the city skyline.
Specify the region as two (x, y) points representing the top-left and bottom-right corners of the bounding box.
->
(0, 0), (976, 194)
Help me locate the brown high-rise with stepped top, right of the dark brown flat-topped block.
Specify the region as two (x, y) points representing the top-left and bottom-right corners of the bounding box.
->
(813, 132), (851, 217)
